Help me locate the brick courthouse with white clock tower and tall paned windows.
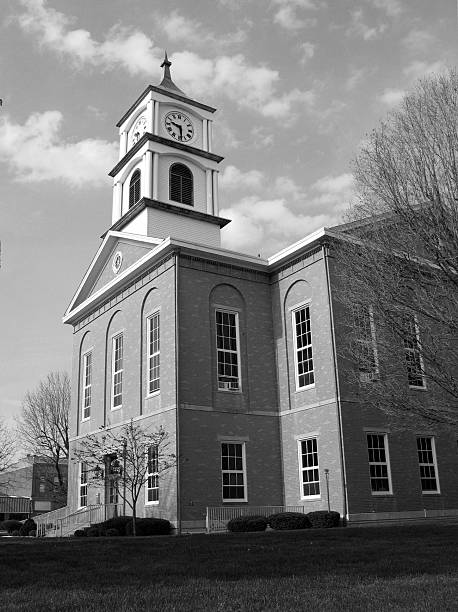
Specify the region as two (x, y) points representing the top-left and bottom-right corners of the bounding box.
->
(64, 57), (458, 529)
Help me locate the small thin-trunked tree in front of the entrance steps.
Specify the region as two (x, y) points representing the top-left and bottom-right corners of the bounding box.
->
(72, 421), (176, 535)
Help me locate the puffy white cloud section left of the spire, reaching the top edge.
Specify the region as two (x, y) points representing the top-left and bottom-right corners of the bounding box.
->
(15, 0), (161, 75)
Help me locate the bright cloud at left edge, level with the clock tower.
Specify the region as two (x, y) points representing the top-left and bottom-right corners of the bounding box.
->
(0, 111), (117, 188)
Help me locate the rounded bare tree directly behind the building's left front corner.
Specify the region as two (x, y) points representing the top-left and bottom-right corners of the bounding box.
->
(18, 372), (70, 498)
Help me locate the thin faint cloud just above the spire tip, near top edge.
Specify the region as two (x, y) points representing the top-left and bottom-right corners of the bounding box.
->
(156, 10), (246, 48)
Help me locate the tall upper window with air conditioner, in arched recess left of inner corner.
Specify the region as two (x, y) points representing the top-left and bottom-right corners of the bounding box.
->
(216, 310), (240, 391)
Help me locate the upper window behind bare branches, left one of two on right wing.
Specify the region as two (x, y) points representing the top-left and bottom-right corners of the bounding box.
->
(353, 305), (378, 382)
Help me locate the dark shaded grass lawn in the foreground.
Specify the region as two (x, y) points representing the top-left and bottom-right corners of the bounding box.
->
(0, 525), (458, 612)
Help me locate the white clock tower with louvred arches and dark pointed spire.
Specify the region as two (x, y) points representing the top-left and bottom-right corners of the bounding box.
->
(110, 53), (229, 247)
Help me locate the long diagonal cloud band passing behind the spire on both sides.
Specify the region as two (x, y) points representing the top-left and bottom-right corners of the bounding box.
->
(16, 0), (313, 118)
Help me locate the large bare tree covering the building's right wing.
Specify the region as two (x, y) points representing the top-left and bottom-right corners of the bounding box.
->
(335, 70), (458, 424)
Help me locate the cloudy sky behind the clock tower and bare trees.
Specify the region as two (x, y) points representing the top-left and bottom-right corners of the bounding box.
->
(0, 0), (456, 424)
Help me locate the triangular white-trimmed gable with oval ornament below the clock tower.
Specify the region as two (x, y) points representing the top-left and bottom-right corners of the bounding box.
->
(65, 231), (162, 316)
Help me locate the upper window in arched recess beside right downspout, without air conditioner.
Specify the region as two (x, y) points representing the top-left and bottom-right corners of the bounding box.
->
(293, 306), (315, 389)
